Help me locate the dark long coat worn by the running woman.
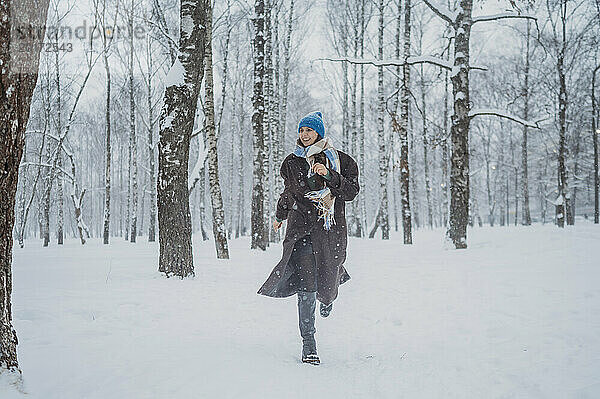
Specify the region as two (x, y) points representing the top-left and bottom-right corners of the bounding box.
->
(258, 150), (359, 304)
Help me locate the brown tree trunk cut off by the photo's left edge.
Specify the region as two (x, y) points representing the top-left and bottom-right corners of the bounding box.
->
(0, 0), (49, 374)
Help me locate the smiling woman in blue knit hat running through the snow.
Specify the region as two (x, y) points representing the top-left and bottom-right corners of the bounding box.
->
(258, 112), (359, 364)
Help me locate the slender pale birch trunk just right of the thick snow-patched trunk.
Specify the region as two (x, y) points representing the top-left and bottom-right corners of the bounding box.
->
(204, 0), (229, 259)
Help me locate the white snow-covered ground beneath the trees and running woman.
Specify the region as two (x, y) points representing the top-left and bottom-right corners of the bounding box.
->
(0, 221), (600, 399)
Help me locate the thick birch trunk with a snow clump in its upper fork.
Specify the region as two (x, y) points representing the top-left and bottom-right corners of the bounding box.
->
(157, 0), (209, 278)
